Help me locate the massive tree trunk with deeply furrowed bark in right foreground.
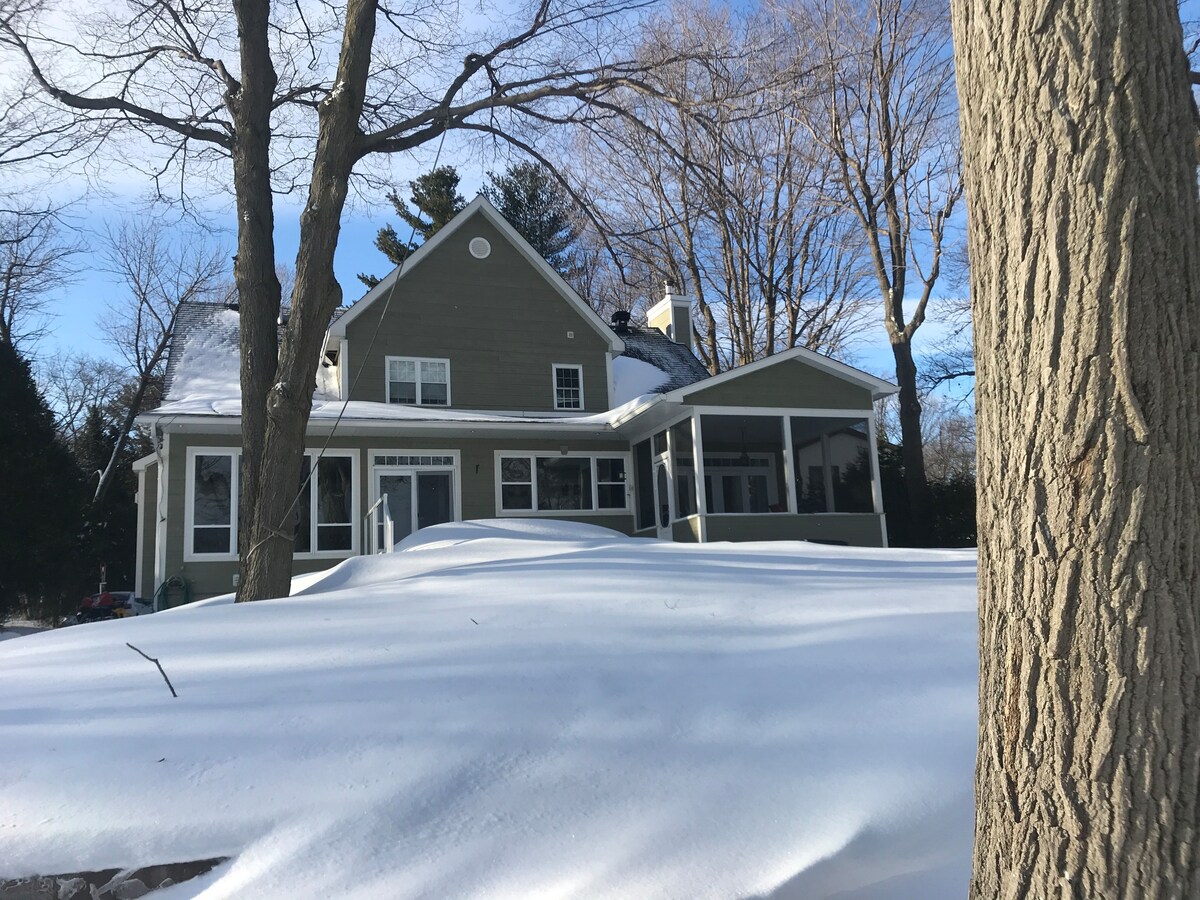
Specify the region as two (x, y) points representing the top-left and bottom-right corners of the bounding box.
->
(954, 0), (1200, 900)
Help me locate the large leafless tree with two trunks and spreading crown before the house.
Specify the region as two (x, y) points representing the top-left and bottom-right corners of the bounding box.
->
(0, 0), (700, 600)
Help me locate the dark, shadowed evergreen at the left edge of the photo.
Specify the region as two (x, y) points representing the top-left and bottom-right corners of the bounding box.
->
(0, 342), (84, 618)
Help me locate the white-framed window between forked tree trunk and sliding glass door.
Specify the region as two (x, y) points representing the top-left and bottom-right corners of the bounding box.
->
(294, 451), (356, 556)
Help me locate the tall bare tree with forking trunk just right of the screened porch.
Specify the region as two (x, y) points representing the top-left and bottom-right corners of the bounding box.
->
(791, 0), (962, 542)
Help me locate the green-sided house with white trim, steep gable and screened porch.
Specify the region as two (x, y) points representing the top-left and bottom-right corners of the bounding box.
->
(136, 197), (895, 605)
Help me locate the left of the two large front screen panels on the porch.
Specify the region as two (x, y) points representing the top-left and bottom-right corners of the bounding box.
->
(701, 415), (787, 515)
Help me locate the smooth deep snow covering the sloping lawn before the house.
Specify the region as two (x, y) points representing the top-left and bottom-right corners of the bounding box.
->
(0, 522), (976, 900)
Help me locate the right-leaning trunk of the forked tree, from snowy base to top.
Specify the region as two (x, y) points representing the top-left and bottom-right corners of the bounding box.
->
(238, 0), (376, 600)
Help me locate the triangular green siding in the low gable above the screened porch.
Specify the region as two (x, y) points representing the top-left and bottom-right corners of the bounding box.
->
(683, 360), (871, 410)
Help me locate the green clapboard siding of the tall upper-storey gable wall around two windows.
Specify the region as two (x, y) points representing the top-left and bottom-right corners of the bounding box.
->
(346, 214), (610, 412)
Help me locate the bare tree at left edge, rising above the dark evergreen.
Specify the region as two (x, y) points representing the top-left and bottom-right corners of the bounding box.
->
(0, 202), (79, 349)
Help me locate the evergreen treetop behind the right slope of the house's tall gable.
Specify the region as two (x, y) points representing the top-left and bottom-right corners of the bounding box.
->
(484, 162), (580, 276)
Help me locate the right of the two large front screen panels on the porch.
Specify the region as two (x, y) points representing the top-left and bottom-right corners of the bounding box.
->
(790, 415), (875, 512)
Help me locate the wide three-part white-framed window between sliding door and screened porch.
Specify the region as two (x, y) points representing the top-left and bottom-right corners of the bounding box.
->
(497, 454), (629, 514)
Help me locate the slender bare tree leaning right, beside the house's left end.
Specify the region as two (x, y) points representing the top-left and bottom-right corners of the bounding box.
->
(92, 218), (228, 505)
